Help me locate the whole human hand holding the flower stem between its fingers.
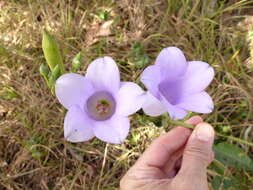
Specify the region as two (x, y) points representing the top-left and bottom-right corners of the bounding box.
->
(120, 116), (214, 190)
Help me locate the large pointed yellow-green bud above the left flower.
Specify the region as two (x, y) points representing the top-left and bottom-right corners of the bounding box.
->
(42, 31), (65, 74)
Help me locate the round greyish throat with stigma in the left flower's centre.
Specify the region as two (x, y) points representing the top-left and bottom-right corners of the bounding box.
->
(86, 91), (116, 121)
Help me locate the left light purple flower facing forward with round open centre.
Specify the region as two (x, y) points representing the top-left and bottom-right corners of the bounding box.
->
(55, 57), (145, 144)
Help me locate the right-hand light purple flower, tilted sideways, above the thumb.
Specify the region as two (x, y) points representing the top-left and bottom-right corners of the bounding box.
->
(141, 47), (214, 119)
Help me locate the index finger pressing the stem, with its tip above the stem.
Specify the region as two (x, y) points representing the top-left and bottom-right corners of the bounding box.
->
(138, 116), (202, 168)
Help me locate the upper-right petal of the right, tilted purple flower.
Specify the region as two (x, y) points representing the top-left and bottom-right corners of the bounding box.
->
(181, 61), (214, 93)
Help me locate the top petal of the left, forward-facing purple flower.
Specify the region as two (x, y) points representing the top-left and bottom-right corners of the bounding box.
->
(86, 57), (120, 92)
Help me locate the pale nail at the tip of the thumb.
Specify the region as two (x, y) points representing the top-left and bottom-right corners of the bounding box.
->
(196, 123), (214, 142)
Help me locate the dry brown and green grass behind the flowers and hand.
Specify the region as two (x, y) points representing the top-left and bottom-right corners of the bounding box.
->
(0, 0), (253, 190)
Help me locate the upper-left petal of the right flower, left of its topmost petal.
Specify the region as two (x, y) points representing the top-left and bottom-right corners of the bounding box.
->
(141, 65), (161, 98)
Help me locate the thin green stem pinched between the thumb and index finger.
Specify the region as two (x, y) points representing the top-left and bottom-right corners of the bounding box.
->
(170, 120), (253, 147)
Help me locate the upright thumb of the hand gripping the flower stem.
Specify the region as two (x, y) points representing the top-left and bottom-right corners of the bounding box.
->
(179, 123), (214, 177)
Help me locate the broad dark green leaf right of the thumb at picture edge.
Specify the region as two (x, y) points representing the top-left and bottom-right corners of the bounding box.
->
(214, 143), (253, 171)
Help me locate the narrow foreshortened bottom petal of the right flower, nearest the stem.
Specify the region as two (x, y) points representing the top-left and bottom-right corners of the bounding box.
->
(161, 96), (187, 120)
